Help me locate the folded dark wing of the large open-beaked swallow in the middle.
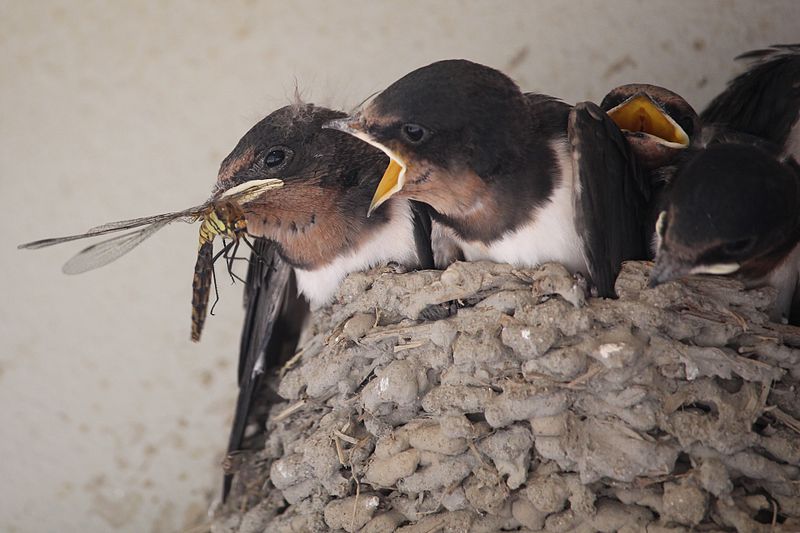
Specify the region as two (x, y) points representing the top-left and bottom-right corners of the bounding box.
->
(568, 102), (650, 297)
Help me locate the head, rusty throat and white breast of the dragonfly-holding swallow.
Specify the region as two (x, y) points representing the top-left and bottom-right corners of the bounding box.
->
(217, 104), (430, 306)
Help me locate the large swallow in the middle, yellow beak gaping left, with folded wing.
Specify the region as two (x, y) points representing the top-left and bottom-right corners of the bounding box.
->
(327, 60), (649, 296)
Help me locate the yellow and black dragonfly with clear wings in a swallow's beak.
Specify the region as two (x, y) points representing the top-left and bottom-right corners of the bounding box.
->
(18, 179), (283, 342)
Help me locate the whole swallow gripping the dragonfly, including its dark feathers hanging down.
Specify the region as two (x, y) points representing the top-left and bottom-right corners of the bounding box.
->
(217, 103), (433, 499)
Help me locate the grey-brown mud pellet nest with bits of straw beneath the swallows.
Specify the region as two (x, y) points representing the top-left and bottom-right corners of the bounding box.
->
(211, 262), (800, 533)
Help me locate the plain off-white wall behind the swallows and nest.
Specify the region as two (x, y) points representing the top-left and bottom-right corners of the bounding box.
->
(0, 0), (800, 532)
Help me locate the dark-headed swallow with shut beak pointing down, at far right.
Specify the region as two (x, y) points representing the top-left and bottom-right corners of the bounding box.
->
(650, 138), (800, 320)
